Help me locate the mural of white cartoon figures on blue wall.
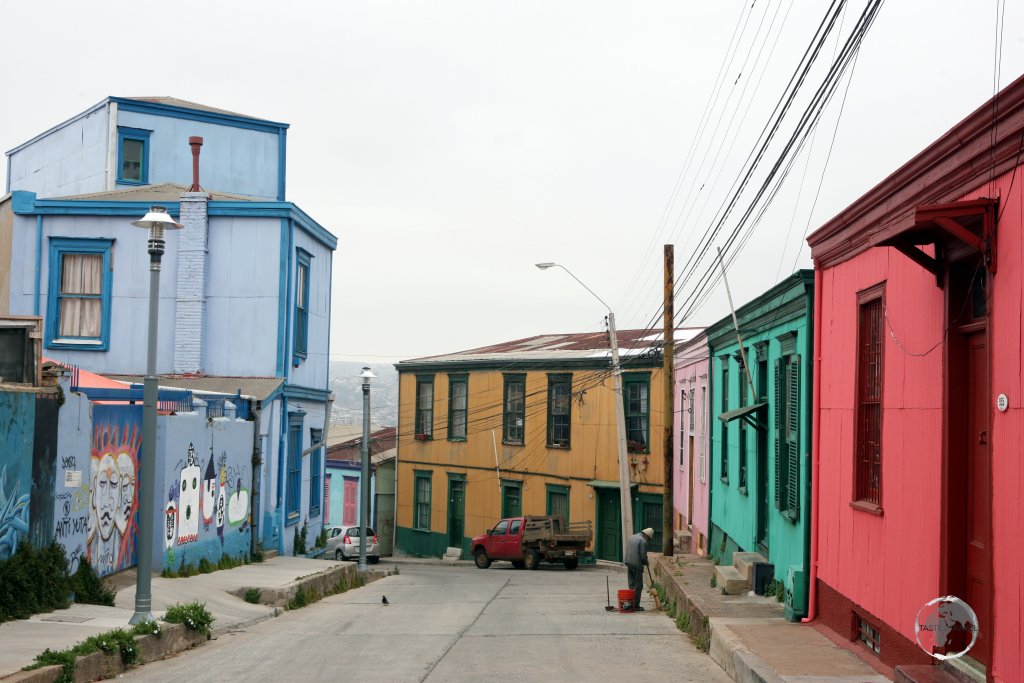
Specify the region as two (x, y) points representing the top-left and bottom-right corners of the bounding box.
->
(164, 440), (250, 569)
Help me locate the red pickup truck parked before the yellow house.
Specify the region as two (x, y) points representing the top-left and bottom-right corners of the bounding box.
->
(471, 516), (594, 569)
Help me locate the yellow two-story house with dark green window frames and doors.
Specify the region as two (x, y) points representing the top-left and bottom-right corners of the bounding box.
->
(395, 331), (665, 561)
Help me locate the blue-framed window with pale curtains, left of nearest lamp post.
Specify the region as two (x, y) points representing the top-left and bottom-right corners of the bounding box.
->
(46, 238), (114, 351)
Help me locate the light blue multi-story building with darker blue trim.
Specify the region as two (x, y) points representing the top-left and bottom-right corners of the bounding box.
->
(0, 97), (337, 553)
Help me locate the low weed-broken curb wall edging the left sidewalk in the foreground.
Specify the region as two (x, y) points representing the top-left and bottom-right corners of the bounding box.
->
(0, 623), (207, 683)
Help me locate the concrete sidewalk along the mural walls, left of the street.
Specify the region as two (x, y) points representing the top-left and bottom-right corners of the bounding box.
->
(0, 557), (372, 679)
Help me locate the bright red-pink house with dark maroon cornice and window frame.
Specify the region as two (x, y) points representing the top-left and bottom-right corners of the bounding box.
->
(808, 78), (1024, 682)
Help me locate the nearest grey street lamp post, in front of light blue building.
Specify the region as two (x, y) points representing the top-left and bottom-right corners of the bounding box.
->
(129, 206), (182, 624)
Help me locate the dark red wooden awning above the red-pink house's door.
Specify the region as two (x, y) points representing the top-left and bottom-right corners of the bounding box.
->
(878, 199), (997, 288)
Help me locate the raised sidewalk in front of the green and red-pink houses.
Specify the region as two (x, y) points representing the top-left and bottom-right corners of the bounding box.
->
(650, 554), (891, 683)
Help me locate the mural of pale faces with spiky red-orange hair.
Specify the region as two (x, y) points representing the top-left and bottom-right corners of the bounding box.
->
(86, 404), (142, 575)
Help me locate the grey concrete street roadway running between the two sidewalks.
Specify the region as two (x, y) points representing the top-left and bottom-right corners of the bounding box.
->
(124, 562), (730, 682)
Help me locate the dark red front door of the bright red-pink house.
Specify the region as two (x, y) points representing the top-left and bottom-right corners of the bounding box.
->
(963, 330), (992, 664)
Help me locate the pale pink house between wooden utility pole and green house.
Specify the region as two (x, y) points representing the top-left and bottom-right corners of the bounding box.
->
(672, 332), (711, 555)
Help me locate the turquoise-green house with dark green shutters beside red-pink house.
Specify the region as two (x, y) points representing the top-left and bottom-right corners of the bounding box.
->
(708, 270), (814, 621)
